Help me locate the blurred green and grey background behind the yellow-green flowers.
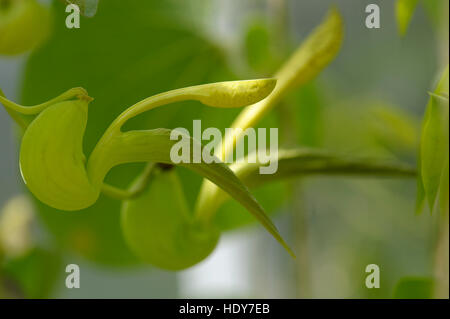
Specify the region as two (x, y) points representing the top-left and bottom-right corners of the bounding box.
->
(0, 0), (448, 298)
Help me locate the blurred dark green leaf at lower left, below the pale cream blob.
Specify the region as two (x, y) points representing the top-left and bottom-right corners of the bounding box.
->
(5, 248), (62, 298)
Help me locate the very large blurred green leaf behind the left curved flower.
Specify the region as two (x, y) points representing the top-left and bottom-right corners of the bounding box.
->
(22, 0), (232, 265)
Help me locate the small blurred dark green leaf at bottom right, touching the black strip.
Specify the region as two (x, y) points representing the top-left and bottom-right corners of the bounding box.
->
(393, 277), (434, 299)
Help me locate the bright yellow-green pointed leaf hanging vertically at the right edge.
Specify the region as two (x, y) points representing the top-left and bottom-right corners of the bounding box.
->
(420, 67), (449, 212)
